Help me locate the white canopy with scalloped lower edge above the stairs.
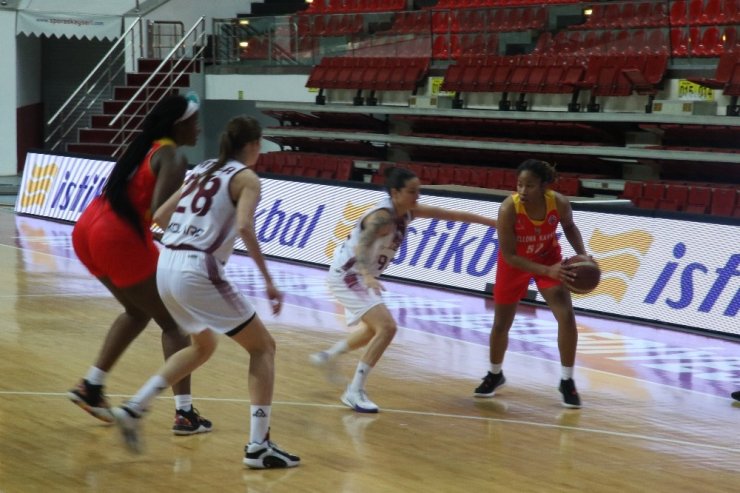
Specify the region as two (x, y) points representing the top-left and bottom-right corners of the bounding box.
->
(16, 0), (137, 40)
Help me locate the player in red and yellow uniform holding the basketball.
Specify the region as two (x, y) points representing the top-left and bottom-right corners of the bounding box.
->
(474, 159), (586, 408)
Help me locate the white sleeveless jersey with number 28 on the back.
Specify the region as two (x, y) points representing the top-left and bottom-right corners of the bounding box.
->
(162, 160), (247, 263)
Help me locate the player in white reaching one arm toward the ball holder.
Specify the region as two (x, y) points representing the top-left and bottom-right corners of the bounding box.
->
(310, 167), (496, 413)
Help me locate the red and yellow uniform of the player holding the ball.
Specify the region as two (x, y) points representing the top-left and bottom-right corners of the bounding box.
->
(493, 190), (562, 304)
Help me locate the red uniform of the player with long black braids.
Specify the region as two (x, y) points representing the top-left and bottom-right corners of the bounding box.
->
(72, 139), (175, 288)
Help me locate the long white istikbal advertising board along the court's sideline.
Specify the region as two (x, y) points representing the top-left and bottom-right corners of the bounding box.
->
(16, 153), (740, 336)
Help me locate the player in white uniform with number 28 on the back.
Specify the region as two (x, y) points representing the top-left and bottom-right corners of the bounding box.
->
(112, 117), (300, 469)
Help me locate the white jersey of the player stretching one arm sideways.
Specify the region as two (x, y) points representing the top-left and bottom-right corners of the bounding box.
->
(331, 197), (413, 277)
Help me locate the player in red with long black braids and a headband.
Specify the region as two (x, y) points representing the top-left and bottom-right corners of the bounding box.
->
(68, 95), (212, 435)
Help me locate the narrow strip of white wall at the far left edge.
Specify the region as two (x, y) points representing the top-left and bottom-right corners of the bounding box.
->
(0, 9), (21, 176)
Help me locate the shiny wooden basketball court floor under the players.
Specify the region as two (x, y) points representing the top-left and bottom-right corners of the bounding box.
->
(0, 208), (740, 493)
